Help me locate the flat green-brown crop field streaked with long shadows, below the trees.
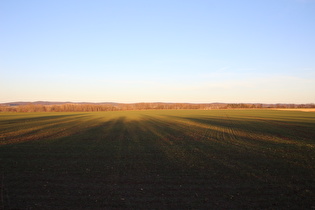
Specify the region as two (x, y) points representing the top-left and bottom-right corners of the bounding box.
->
(0, 110), (315, 209)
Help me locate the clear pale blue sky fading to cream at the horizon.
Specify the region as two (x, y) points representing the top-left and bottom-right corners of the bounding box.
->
(0, 0), (315, 104)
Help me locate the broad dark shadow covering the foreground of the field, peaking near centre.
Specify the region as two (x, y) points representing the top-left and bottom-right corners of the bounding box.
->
(0, 116), (315, 209)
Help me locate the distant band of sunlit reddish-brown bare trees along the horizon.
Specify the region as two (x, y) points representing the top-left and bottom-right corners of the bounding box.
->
(0, 102), (315, 112)
